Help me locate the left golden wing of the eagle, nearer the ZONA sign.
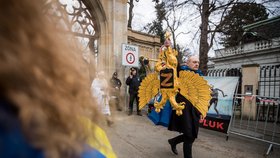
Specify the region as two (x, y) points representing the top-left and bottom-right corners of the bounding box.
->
(138, 73), (160, 109)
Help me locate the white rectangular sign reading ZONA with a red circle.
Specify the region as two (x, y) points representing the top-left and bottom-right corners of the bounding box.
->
(122, 44), (139, 67)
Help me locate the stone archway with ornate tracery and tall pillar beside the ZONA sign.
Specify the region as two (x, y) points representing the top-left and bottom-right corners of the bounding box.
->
(46, 0), (127, 79)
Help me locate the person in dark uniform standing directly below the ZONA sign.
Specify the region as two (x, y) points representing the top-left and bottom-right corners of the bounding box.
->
(126, 67), (142, 116)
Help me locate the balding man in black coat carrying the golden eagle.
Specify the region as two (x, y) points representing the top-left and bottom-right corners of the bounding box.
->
(168, 56), (205, 158)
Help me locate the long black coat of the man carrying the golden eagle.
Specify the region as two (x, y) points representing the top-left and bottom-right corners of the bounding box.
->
(168, 93), (200, 138)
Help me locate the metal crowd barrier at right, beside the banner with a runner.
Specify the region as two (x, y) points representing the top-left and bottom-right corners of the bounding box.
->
(227, 94), (280, 156)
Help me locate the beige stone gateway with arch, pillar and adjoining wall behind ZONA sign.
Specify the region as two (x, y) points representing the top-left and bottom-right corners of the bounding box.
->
(46, 0), (161, 100)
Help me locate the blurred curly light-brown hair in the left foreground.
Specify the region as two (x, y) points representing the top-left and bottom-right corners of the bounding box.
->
(0, 0), (98, 158)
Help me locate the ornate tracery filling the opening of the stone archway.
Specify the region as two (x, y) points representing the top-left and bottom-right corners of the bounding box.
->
(46, 0), (99, 63)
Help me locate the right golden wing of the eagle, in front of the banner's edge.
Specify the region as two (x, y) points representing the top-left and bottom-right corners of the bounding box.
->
(179, 71), (211, 117)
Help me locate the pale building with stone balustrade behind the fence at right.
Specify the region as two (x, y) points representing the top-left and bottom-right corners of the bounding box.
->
(208, 16), (280, 97)
